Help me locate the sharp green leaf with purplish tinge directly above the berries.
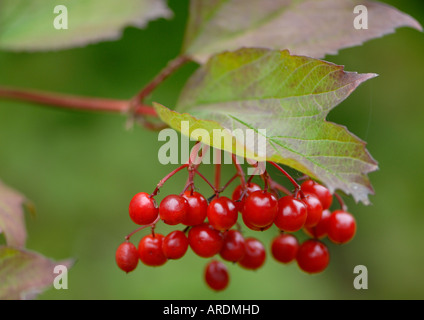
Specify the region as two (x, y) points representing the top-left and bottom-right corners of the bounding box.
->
(155, 48), (377, 204)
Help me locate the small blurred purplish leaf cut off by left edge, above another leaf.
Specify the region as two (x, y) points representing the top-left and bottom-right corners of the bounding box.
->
(0, 181), (27, 247)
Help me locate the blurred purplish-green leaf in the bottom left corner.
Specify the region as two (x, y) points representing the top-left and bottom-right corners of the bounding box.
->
(0, 246), (73, 300)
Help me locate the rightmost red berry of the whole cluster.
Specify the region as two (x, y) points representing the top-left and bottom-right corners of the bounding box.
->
(328, 210), (356, 244)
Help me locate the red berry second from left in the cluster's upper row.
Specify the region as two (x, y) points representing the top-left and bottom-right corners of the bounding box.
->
(159, 194), (189, 226)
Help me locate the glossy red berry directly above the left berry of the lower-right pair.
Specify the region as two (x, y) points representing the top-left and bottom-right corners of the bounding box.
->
(274, 196), (308, 232)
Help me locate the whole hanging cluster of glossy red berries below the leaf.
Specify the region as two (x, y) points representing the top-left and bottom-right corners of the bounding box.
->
(116, 180), (356, 290)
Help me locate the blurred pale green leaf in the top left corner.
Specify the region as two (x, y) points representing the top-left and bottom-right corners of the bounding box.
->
(0, 0), (172, 51)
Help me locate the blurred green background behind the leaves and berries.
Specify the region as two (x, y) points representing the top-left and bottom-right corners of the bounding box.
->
(0, 0), (424, 299)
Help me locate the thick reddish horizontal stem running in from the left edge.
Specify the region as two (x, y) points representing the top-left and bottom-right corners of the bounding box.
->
(0, 87), (157, 117)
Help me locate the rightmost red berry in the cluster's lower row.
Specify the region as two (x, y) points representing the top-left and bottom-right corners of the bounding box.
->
(296, 239), (330, 274)
